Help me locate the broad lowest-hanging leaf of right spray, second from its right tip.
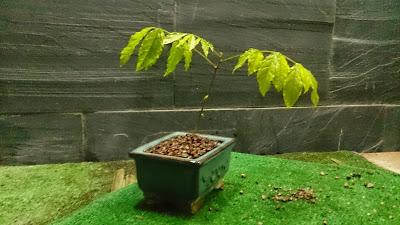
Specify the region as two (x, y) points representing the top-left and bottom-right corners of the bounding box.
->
(283, 67), (303, 107)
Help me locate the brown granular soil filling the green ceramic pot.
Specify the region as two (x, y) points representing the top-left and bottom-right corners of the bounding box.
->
(147, 134), (221, 159)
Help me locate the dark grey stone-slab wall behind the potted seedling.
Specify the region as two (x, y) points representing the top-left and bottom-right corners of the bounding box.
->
(0, 0), (400, 164)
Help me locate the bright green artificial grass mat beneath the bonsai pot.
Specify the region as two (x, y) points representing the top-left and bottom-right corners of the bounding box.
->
(55, 153), (400, 225)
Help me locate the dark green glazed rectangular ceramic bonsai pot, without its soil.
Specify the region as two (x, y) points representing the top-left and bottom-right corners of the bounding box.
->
(129, 132), (234, 212)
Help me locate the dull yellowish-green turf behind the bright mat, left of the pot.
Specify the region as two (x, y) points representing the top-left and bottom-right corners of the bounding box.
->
(0, 162), (134, 225)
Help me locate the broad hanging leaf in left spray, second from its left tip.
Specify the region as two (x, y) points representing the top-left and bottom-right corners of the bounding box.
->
(136, 29), (165, 71)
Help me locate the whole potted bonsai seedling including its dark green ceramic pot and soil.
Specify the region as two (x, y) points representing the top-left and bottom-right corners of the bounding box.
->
(120, 27), (319, 213)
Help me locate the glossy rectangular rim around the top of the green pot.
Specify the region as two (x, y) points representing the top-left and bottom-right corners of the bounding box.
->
(129, 131), (235, 165)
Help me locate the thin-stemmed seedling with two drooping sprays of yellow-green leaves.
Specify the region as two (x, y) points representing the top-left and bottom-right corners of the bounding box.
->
(120, 27), (319, 130)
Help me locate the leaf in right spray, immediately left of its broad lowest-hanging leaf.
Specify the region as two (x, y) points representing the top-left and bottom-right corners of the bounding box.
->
(266, 52), (290, 92)
